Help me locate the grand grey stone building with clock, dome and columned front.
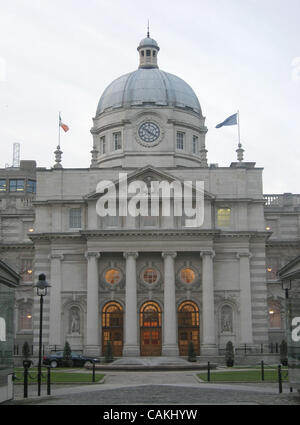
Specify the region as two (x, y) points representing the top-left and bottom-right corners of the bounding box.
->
(0, 34), (300, 357)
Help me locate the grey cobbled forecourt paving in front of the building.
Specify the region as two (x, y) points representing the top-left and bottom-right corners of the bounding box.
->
(5, 371), (300, 406)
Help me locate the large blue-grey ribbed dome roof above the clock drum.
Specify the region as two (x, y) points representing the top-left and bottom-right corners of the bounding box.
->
(96, 68), (202, 115)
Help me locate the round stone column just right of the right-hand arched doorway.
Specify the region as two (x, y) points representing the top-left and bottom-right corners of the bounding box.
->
(200, 251), (218, 355)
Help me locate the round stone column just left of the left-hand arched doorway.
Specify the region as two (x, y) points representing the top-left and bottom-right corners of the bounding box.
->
(85, 252), (101, 356)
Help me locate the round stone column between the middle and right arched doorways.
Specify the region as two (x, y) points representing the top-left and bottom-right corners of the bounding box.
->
(162, 252), (179, 356)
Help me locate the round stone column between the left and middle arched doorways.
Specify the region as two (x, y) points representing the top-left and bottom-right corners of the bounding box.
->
(123, 252), (140, 357)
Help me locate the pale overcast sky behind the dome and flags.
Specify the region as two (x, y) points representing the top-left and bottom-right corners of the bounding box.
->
(0, 0), (300, 194)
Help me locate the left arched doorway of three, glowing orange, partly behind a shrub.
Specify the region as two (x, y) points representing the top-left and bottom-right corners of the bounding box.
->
(102, 301), (124, 357)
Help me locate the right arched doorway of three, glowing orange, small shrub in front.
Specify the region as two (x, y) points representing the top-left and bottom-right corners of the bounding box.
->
(178, 301), (200, 356)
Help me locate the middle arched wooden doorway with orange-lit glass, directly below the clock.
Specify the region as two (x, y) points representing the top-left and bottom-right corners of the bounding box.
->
(140, 301), (161, 356)
